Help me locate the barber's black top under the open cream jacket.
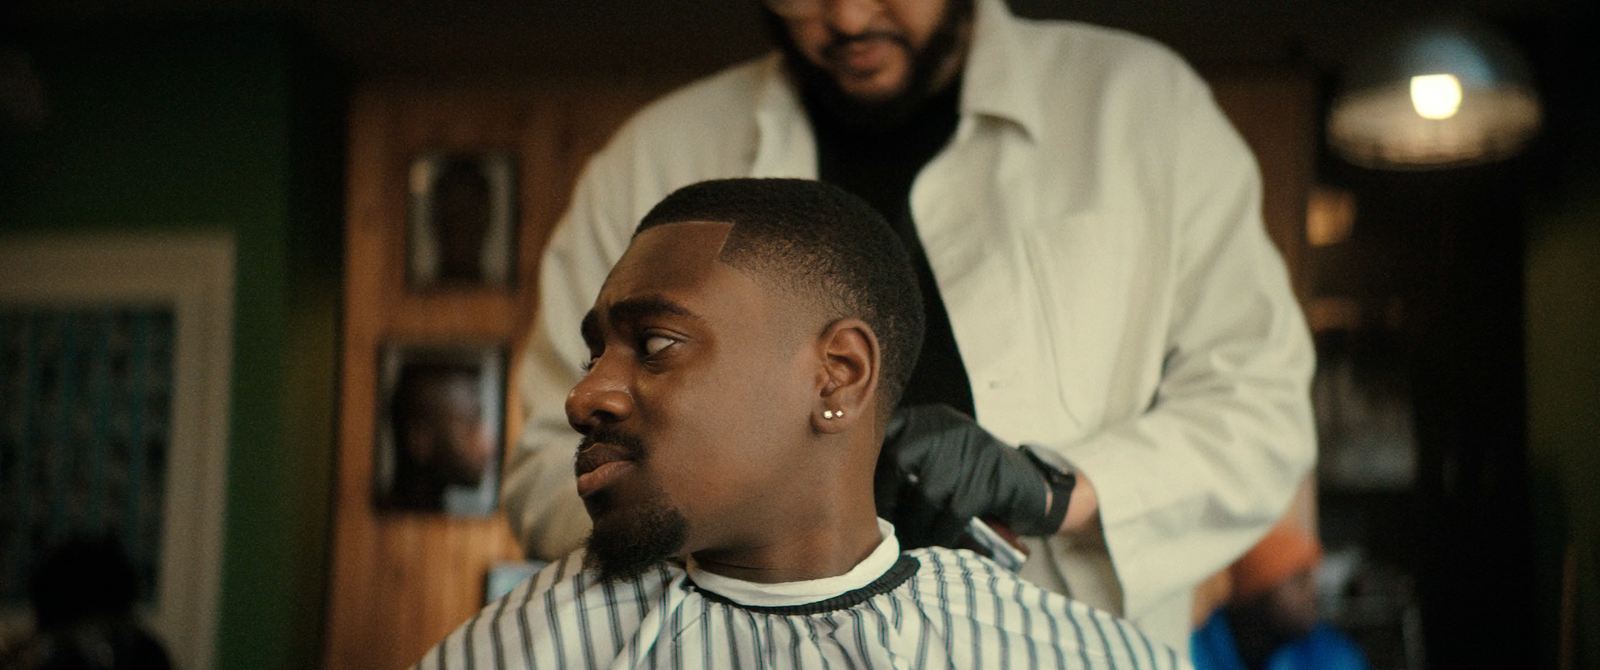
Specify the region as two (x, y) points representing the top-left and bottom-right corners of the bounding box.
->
(802, 82), (976, 416)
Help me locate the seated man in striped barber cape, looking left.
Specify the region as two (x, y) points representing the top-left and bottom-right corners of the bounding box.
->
(418, 179), (1184, 668)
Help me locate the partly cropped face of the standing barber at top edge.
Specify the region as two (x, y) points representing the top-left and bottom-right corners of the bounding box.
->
(773, 0), (963, 102)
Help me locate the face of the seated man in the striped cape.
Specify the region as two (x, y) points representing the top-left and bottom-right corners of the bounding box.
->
(566, 222), (816, 576)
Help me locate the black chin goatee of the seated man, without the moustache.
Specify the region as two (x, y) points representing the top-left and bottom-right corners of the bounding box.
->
(584, 491), (690, 580)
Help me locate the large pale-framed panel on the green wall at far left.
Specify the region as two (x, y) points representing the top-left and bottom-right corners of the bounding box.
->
(0, 233), (237, 670)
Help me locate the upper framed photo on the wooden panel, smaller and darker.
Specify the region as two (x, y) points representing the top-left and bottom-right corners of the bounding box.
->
(406, 150), (517, 289)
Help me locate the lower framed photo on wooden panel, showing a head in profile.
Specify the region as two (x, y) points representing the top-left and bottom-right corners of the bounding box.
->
(373, 344), (506, 516)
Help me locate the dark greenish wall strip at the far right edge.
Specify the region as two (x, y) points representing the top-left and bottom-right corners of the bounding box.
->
(1523, 13), (1600, 670)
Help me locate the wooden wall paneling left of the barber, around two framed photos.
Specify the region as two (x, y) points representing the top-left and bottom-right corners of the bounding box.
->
(326, 82), (664, 668)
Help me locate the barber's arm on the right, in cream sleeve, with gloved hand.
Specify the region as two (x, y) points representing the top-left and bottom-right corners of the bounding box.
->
(880, 63), (1315, 616)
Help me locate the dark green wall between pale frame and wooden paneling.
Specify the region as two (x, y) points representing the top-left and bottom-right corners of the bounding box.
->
(0, 21), (344, 668)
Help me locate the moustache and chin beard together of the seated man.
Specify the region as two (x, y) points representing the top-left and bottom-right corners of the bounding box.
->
(578, 427), (690, 580)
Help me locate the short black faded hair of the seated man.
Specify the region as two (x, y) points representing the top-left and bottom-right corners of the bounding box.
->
(634, 179), (923, 408)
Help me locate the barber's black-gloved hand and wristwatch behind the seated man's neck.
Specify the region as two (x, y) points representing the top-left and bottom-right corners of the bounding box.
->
(877, 405), (1075, 548)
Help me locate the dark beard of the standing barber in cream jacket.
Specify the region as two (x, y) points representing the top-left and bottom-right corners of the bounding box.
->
(762, 0), (973, 131)
